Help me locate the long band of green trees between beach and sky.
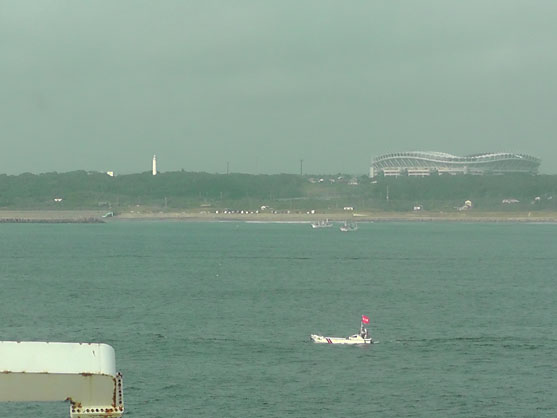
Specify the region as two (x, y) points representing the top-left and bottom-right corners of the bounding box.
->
(0, 171), (557, 211)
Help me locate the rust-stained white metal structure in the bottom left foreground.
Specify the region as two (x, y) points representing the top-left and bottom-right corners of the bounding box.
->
(0, 341), (124, 418)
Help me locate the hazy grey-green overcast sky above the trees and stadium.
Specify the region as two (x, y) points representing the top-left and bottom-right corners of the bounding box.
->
(0, 0), (557, 174)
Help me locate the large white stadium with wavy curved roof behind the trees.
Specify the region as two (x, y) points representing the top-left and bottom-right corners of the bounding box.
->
(369, 151), (541, 177)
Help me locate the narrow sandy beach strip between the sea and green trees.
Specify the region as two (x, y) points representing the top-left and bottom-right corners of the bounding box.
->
(0, 209), (557, 223)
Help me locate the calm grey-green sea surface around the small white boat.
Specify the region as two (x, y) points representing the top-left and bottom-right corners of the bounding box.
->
(0, 222), (557, 418)
